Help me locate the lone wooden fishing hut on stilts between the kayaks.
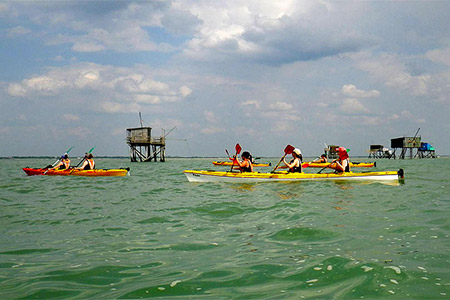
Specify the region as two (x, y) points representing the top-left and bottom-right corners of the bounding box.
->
(127, 127), (166, 162)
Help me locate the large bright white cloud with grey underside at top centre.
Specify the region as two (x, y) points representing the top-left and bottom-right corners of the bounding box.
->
(184, 1), (367, 64)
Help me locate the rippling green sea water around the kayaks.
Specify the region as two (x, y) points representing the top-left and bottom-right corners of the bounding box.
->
(0, 158), (450, 299)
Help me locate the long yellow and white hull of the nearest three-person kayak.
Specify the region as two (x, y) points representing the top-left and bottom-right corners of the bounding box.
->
(184, 169), (403, 182)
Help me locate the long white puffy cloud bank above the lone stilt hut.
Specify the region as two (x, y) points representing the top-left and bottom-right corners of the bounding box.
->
(7, 64), (192, 112)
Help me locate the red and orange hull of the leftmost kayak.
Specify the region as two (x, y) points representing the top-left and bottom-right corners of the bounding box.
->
(23, 168), (130, 177)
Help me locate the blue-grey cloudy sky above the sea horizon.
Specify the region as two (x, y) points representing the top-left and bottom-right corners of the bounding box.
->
(0, 0), (450, 157)
